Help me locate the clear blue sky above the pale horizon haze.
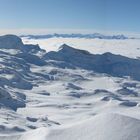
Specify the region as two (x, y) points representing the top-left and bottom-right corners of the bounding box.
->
(0, 0), (140, 32)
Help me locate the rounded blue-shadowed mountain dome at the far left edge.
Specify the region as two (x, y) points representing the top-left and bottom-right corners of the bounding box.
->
(0, 35), (23, 49)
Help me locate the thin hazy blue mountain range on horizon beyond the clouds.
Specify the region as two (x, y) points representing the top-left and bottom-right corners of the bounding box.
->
(20, 33), (131, 39)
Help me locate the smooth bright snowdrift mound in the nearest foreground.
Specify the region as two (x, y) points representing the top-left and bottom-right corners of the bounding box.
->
(0, 113), (140, 140)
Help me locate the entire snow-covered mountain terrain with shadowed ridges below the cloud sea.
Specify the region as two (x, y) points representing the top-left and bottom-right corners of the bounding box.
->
(0, 35), (140, 140)
